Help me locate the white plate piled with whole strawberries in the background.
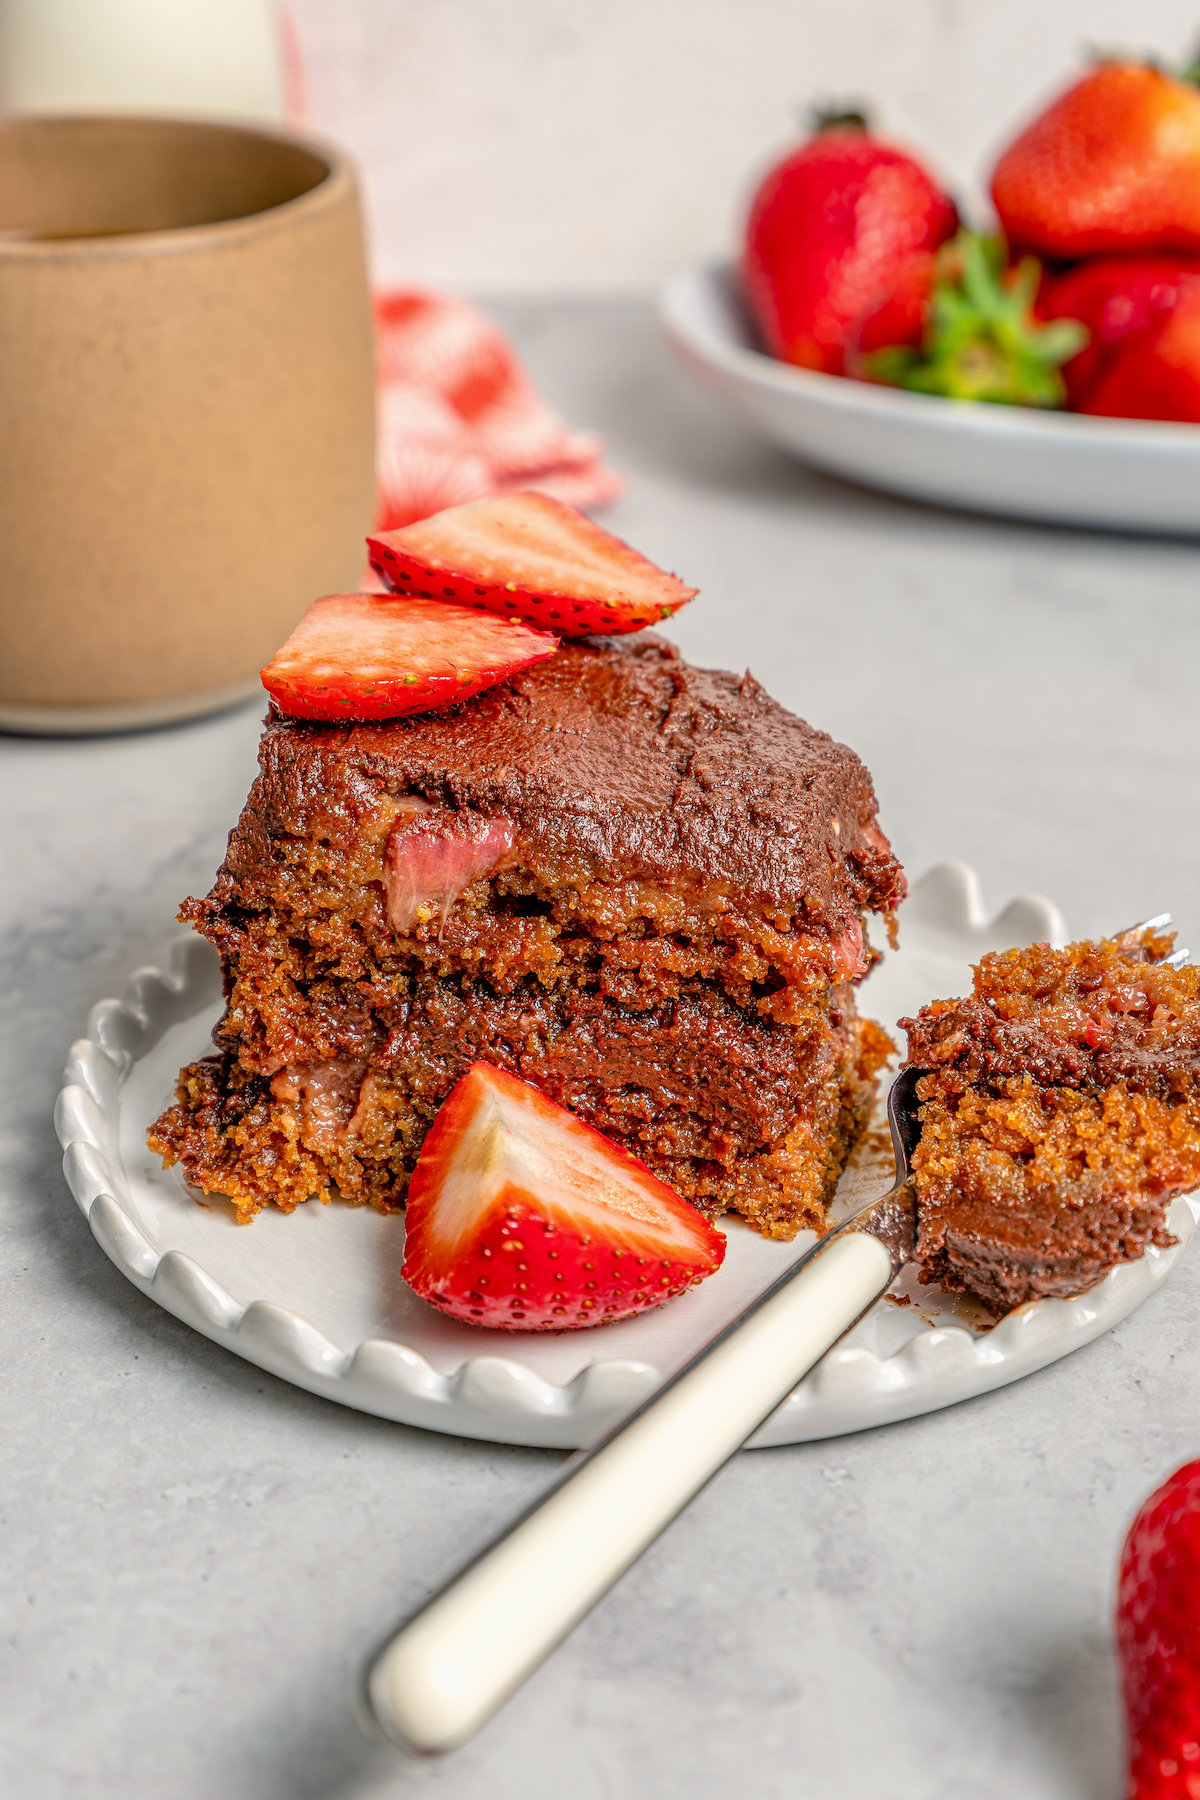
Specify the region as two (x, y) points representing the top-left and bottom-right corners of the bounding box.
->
(662, 50), (1200, 535)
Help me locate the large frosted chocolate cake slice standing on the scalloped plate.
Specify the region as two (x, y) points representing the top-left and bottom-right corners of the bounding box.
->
(151, 634), (903, 1237)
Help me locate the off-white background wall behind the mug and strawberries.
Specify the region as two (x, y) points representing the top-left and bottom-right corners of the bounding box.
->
(290, 0), (1200, 292)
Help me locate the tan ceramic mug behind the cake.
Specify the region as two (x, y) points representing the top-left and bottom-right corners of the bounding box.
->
(0, 117), (374, 731)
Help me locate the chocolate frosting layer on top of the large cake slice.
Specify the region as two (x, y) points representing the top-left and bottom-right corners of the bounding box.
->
(261, 632), (903, 931)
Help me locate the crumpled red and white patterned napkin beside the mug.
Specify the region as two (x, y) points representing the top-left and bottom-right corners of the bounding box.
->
(374, 288), (621, 531)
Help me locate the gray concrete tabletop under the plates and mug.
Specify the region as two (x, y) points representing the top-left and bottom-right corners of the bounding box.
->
(0, 304), (1200, 1800)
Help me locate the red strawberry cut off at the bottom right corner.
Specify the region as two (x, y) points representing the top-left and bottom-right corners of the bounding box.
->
(1117, 1462), (1200, 1800)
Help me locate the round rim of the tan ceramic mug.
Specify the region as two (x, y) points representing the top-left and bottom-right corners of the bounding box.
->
(0, 112), (356, 261)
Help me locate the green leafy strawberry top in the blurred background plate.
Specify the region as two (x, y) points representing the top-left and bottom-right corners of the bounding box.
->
(862, 230), (1087, 407)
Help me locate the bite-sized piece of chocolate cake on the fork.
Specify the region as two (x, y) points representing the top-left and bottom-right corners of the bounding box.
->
(901, 932), (1200, 1312)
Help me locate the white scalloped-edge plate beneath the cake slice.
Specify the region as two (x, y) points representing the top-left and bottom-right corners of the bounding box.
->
(56, 862), (1195, 1447)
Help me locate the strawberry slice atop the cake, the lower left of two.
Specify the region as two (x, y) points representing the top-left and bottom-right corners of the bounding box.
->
(263, 594), (558, 718)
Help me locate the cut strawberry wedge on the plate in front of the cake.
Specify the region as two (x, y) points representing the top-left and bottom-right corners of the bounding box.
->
(401, 1062), (725, 1332)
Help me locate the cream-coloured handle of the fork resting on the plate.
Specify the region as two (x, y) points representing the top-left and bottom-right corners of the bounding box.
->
(367, 1231), (892, 1755)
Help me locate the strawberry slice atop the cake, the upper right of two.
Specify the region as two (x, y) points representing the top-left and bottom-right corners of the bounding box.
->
(367, 493), (696, 637)
